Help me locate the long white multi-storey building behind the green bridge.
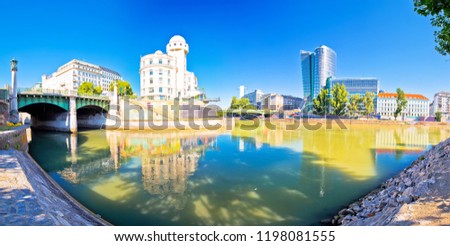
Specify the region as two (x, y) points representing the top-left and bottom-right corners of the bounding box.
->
(42, 59), (122, 95)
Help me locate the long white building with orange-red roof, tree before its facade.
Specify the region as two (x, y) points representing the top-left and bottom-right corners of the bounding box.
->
(377, 92), (430, 119)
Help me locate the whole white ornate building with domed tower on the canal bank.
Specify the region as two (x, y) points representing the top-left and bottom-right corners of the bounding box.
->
(139, 35), (200, 100)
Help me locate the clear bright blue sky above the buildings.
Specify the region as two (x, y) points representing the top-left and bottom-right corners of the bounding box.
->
(0, 0), (450, 106)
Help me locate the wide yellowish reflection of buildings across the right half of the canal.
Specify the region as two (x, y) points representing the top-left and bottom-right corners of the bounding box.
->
(232, 125), (450, 181)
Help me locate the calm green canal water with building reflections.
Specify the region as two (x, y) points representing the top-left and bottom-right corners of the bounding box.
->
(30, 126), (450, 225)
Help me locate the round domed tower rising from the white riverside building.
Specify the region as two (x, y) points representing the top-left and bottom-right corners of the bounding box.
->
(166, 35), (189, 97)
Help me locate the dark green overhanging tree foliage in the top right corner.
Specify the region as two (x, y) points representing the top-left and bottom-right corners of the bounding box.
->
(414, 0), (450, 56)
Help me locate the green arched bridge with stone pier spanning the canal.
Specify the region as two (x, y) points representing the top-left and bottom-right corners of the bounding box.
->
(17, 88), (110, 132)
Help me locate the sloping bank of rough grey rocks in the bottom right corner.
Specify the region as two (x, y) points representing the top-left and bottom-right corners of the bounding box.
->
(331, 138), (450, 226)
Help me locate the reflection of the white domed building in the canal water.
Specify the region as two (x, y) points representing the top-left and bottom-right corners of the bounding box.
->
(107, 131), (217, 195)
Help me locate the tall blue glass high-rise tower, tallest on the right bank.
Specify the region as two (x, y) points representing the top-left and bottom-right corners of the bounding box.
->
(300, 45), (337, 107)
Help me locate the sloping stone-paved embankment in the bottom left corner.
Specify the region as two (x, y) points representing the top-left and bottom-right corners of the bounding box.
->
(0, 150), (109, 226)
